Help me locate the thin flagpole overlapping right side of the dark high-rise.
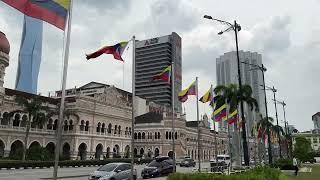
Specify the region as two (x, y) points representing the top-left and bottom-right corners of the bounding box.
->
(171, 61), (176, 172)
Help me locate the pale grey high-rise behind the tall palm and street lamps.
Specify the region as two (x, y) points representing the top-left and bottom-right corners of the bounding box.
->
(216, 51), (265, 135)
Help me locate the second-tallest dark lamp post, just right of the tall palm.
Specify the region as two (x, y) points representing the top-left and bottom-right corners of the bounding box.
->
(241, 62), (272, 164)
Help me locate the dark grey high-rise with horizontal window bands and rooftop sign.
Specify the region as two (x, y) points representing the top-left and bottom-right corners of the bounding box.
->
(135, 32), (182, 112)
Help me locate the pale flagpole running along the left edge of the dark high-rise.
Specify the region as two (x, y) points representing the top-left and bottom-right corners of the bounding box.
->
(131, 36), (136, 179)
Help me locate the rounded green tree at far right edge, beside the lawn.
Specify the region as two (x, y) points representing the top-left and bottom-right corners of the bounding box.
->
(293, 137), (312, 162)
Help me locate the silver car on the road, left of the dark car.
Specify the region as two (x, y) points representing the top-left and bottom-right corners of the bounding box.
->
(89, 163), (137, 180)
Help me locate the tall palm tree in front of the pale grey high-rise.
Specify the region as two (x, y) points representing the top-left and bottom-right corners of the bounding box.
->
(214, 84), (259, 164)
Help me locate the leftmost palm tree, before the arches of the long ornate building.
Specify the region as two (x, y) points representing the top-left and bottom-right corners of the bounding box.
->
(11, 96), (48, 161)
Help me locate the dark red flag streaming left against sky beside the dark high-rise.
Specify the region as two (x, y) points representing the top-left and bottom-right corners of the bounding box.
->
(86, 41), (128, 61)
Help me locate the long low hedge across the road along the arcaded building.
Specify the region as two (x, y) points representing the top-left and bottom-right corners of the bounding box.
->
(0, 158), (152, 169)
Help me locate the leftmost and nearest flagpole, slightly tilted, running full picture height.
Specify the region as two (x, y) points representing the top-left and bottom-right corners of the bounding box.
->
(53, 0), (72, 180)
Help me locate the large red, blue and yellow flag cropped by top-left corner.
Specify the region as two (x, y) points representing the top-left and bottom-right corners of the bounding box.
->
(2, 0), (70, 30)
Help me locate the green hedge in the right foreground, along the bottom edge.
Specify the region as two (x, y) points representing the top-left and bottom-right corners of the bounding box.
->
(168, 167), (285, 180)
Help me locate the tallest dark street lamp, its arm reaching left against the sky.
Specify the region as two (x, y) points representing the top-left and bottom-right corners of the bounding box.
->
(203, 15), (249, 166)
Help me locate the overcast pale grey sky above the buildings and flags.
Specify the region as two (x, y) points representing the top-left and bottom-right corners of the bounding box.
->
(0, 0), (320, 130)
